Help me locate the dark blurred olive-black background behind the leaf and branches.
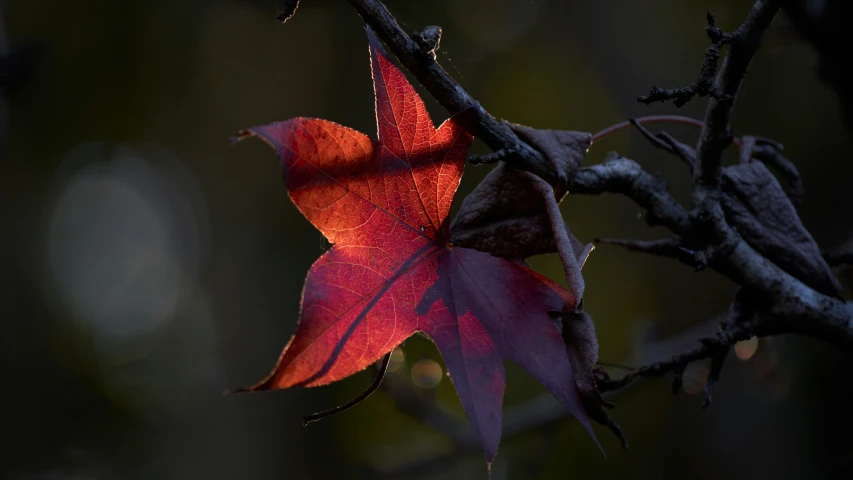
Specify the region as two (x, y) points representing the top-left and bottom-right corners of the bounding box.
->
(0, 0), (853, 479)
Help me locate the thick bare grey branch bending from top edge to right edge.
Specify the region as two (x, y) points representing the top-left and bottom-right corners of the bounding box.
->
(632, 0), (853, 356)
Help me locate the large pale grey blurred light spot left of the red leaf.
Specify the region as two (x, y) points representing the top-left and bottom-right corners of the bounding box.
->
(45, 142), (203, 349)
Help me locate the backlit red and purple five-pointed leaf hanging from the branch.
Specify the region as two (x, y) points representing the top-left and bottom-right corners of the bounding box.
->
(233, 30), (592, 461)
